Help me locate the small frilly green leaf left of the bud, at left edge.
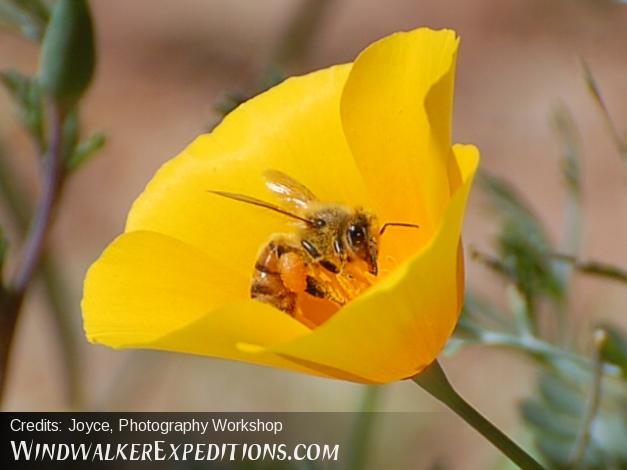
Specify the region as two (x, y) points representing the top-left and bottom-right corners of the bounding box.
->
(0, 70), (45, 148)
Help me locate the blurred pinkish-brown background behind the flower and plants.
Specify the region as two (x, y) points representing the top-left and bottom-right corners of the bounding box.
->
(0, 0), (627, 468)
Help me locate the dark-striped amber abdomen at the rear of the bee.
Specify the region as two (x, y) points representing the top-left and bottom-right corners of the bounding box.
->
(250, 242), (296, 315)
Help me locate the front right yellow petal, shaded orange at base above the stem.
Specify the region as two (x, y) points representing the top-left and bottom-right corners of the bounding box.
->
(272, 146), (479, 383)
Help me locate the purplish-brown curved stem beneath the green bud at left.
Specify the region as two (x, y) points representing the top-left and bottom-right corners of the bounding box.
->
(0, 104), (64, 402)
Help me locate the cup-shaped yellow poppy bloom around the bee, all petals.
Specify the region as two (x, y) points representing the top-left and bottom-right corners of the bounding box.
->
(82, 29), (479, 383)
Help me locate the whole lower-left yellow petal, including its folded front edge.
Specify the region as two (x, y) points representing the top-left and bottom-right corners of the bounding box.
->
(82, 232), (325, 375)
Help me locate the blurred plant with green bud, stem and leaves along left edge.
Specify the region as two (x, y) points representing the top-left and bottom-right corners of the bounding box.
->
(0, 0), (105, 403)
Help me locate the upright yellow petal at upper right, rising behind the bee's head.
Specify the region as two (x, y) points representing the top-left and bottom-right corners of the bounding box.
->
(341, 29), (459, 261)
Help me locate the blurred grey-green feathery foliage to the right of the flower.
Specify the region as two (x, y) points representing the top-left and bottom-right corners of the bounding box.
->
(447, 88), (627, 469)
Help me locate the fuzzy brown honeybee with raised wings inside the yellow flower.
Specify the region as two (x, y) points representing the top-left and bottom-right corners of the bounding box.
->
(209, 170), (418, 324)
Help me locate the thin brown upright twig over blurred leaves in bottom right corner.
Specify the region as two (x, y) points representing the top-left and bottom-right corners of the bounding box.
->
(569, 329), (607, 469)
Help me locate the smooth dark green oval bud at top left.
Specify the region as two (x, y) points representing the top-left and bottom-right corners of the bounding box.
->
(39, 0), (96, 111)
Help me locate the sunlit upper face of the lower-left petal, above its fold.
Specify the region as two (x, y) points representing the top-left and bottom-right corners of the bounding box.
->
(82, 232), (247, 347)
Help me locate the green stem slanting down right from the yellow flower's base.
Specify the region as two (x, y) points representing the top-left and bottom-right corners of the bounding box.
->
(412, 360), (543, 470)
